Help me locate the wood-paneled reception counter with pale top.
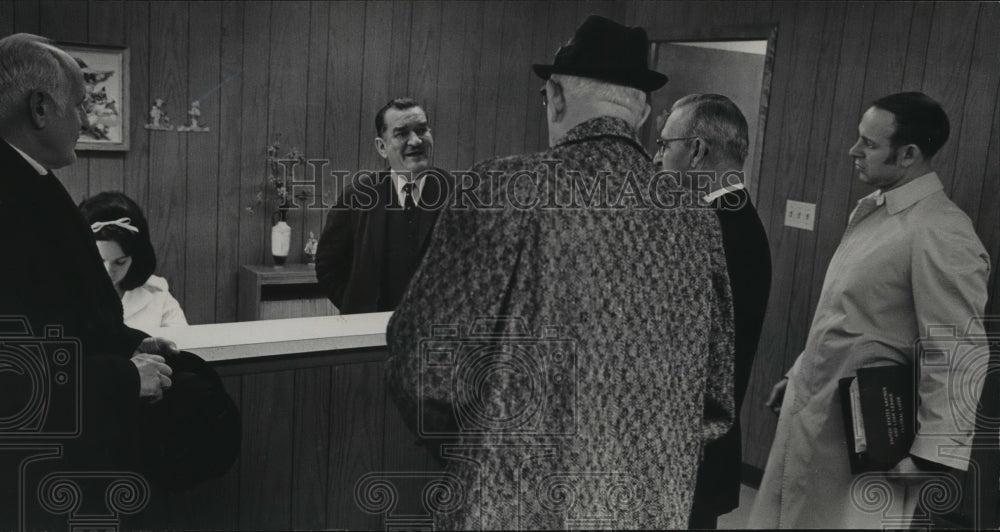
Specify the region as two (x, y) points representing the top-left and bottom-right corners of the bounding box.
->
(129, 313), (436, 530)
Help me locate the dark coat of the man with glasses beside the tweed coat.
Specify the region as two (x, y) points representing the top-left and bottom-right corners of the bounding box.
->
(694, 189), (771, 515)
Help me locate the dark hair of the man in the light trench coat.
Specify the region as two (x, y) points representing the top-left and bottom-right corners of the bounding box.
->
(872, 92), (951, 159)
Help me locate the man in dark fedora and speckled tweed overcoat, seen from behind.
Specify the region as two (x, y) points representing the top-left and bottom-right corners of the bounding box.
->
(386, 16), (733, 529)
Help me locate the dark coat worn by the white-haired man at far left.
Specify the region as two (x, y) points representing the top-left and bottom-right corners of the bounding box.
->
(0, 141), (149, 524)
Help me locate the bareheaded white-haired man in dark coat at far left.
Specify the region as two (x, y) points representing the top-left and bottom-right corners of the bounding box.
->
(0, 33), (176, 530)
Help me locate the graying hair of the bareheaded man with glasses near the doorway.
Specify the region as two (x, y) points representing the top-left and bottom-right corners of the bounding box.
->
(672, 94), (750, 166)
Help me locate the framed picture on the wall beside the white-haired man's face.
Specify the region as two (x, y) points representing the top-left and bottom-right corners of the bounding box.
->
(58, 42), (130, 151)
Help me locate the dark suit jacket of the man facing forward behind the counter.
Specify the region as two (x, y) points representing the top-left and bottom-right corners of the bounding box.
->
(316, 168), (450, 314)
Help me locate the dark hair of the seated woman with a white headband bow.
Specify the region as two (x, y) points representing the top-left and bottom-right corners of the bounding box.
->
(80, 192), (156, 290)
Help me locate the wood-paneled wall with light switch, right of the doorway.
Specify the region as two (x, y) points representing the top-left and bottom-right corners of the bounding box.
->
(626, 1), (1000, 474)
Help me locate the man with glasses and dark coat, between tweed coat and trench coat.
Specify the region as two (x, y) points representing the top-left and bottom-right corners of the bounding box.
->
(654, 94), (771, 529)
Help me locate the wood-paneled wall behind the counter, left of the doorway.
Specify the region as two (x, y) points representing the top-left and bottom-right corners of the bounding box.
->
(0, 0), (625, 323)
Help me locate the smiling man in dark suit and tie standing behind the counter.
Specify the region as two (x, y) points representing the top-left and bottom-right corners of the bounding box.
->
(316, 98), (448, 314)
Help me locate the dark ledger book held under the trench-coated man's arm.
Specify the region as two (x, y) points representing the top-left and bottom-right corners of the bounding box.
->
(839, 366), (916, 474)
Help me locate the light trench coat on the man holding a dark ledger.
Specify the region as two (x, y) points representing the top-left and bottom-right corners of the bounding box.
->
(748, 173), (989, 529)
